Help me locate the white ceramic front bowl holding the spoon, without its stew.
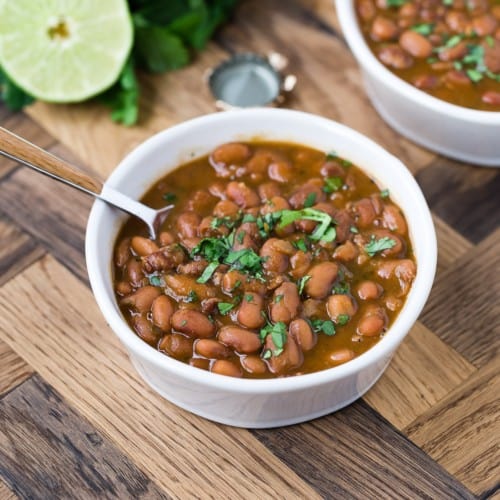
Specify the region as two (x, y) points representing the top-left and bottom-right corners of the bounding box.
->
(86, 109), (436, 428)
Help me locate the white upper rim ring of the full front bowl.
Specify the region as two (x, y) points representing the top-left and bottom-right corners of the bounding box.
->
(85, 108), (437, 394)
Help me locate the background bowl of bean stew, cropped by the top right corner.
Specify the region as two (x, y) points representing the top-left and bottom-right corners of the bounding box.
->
(335, 0), (500, 167)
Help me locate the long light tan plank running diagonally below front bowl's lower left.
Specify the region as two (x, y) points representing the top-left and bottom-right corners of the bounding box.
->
(0, 257), (317, 499)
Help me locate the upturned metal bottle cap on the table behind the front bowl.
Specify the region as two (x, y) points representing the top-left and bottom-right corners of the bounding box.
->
(207, 52), (297, 110)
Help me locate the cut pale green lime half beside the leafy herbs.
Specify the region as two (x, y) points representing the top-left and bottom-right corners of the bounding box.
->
(0, 0), (133, 102)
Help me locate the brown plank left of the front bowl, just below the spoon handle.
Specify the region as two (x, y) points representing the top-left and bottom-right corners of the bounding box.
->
(0, 164), (93, 282)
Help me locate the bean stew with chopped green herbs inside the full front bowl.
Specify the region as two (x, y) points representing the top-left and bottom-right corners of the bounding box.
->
(114, 142), (416, 378)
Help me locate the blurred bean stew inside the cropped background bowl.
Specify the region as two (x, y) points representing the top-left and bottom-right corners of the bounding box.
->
(355, 0), (500, 111)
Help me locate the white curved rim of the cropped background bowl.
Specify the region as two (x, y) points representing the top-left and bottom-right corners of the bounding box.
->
(334, 0), (500, 125)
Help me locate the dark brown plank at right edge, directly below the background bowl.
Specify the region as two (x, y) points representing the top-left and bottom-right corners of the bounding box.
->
(416, 158), (500, 243)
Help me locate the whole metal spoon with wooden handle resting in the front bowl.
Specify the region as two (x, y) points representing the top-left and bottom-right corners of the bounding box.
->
(0, 127), (173, 240)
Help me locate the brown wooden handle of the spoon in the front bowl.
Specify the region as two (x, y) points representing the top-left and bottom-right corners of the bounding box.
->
(0, 127), (103, 195)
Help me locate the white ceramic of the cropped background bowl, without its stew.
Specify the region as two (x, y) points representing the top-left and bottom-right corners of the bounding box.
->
(335, 0), (500, 167)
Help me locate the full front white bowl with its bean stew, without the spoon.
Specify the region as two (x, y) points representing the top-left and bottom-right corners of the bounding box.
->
(86, 109), (437, 428)
